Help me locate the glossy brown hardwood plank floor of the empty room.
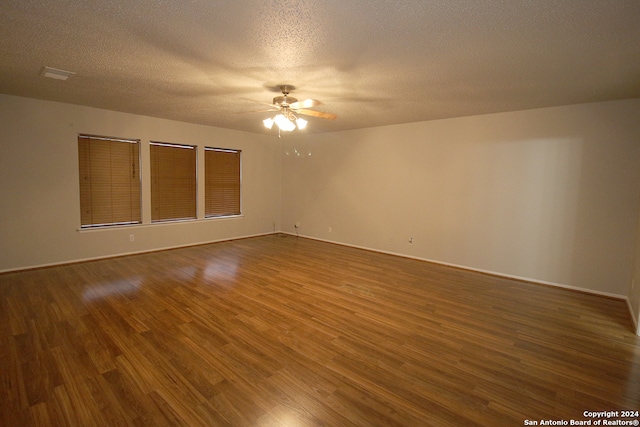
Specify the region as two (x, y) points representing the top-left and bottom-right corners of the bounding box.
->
(0, 235), (640, 427)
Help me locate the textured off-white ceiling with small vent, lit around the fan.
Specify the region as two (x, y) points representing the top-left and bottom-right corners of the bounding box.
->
(0, 0), (640, 133)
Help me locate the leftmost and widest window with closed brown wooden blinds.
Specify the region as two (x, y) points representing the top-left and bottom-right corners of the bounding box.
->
(78, 135), (140, 228)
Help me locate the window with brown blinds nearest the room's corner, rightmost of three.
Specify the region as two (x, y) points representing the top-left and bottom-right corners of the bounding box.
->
(204, 147), (240, 217)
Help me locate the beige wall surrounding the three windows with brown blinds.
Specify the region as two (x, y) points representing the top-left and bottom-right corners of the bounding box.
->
(0, 95), (281, 271)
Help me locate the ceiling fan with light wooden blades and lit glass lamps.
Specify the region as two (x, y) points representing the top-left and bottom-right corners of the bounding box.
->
(246, 85), (337, 132)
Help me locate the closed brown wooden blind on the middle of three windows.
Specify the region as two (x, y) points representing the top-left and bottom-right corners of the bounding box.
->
(150, 142), (196, 222)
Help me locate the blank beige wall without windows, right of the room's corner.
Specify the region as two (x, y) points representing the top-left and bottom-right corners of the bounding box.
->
(282, 100), (640, 297)
